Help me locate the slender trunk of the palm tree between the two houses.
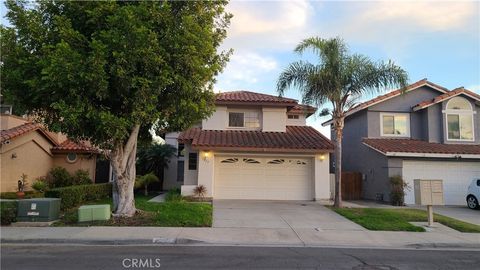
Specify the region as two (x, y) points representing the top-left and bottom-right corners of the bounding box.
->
(333, 117), (344, 207)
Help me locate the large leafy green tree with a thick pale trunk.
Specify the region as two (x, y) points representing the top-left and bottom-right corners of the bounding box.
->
(1, 0), (231, 216)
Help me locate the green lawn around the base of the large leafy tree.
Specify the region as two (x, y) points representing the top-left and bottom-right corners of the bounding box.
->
(54, 196), (212, 227)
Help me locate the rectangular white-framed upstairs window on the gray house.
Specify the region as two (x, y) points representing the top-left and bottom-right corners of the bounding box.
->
(380, 113), (410, 137)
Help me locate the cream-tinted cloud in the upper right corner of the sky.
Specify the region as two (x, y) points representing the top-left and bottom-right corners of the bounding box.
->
(329, 1), (480, 42)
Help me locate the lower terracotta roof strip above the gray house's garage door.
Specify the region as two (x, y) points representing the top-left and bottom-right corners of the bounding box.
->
(363, 138), (480, 155)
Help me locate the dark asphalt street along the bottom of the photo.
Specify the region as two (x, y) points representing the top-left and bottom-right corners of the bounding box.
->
(1, 244), (480, 270)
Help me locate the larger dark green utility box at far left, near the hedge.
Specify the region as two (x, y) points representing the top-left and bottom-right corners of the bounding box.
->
(17, 198), (60, 222)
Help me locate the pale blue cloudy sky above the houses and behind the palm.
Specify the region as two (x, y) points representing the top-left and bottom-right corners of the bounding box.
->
(0, 0), (480, 137)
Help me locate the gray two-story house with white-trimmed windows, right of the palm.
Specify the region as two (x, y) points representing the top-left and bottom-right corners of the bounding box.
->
(323, 79), (480, 205)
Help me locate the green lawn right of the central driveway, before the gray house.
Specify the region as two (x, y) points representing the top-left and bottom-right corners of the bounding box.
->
(331, 208), (480, 233)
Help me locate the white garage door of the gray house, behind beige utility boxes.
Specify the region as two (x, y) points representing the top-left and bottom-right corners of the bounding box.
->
(403, 161), (480, 205)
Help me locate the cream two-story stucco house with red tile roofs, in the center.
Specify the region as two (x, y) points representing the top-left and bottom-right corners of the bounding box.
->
(164, 91), (333, 200)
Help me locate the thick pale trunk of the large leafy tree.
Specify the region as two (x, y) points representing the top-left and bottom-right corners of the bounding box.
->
(110, 125), (140, 217)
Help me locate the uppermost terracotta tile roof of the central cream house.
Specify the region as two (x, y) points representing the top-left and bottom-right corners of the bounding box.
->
(215, 91), (298, 105)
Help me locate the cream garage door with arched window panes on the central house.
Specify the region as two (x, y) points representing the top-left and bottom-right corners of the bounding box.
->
(213, 156), (313, 200)
